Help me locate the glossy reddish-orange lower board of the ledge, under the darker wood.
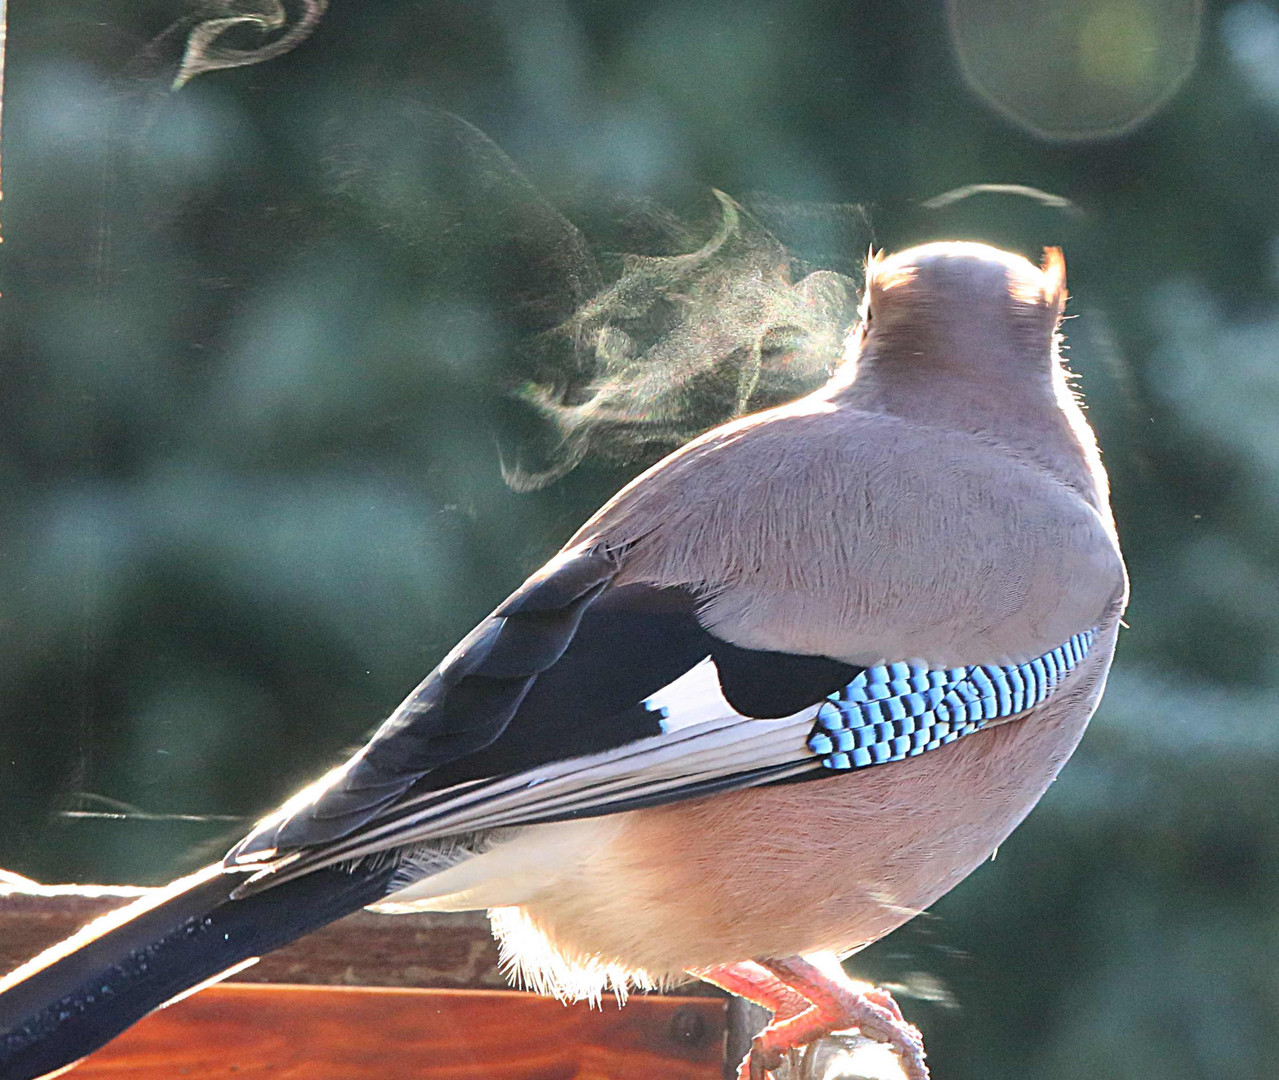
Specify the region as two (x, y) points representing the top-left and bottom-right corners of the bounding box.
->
(73, 984), (724, 1080)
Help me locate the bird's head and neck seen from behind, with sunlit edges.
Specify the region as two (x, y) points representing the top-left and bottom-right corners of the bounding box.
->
(820, 241), (1102, 491)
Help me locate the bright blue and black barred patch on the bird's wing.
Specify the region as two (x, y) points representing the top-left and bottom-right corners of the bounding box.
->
(808, 630), (1096, 769)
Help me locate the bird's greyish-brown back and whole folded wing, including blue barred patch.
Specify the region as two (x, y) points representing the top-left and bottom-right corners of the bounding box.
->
(228, 409), (1122, 869)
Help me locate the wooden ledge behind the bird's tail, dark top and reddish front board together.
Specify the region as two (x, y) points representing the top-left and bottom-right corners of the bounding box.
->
(0, 871), (726, 1080)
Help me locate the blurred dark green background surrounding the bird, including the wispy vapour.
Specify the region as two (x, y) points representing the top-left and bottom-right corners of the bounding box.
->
(0, 0), (1279, 1080)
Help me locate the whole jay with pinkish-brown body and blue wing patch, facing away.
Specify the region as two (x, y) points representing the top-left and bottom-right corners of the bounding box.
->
(0, 241), (1128, 1080)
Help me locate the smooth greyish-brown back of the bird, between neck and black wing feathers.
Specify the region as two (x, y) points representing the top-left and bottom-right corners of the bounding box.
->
(570, 398), (1124, 664)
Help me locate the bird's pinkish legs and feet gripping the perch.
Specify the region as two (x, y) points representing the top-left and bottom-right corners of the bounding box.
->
(700, 957), (929, 1080)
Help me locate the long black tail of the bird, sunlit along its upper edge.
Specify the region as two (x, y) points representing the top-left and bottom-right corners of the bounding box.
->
(0, 862), (394, 1080)
